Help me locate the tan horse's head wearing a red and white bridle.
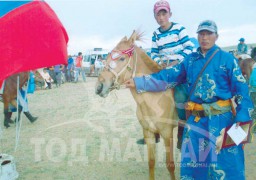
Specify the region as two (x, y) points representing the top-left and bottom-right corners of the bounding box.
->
(95, 31), (141, 97)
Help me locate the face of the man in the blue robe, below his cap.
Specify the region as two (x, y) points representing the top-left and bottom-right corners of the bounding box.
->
(198, 30), (218, 53)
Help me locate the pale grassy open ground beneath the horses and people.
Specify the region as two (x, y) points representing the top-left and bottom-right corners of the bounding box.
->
(0, 77), (256, 180)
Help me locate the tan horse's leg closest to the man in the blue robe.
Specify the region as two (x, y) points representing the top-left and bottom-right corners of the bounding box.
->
(164, 137), (175, 180)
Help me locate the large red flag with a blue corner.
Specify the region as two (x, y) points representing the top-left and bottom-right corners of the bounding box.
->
(0, 1), (68, 80)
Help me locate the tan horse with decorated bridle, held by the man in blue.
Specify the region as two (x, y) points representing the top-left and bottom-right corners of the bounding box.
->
(95, 31), (178, 179)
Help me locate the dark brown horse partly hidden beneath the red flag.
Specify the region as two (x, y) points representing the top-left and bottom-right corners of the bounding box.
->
(2, 72), (29, 128)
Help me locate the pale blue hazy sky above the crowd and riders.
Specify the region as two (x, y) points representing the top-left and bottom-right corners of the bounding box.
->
(46, 0), (256, 54)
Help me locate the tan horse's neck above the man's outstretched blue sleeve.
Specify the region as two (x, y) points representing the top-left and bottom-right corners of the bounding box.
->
(133, 50), (161, 76)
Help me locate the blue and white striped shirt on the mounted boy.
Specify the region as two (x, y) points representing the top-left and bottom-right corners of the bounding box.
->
(151, 22), (194, 64)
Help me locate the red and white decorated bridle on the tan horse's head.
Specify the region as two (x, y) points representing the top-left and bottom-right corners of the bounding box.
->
(105, 45), (137, 90)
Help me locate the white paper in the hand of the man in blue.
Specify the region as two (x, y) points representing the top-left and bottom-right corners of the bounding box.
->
(227, 124), (247, 146)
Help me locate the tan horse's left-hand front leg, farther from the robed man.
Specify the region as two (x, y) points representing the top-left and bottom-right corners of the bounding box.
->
(143, 129), (156, 180)
